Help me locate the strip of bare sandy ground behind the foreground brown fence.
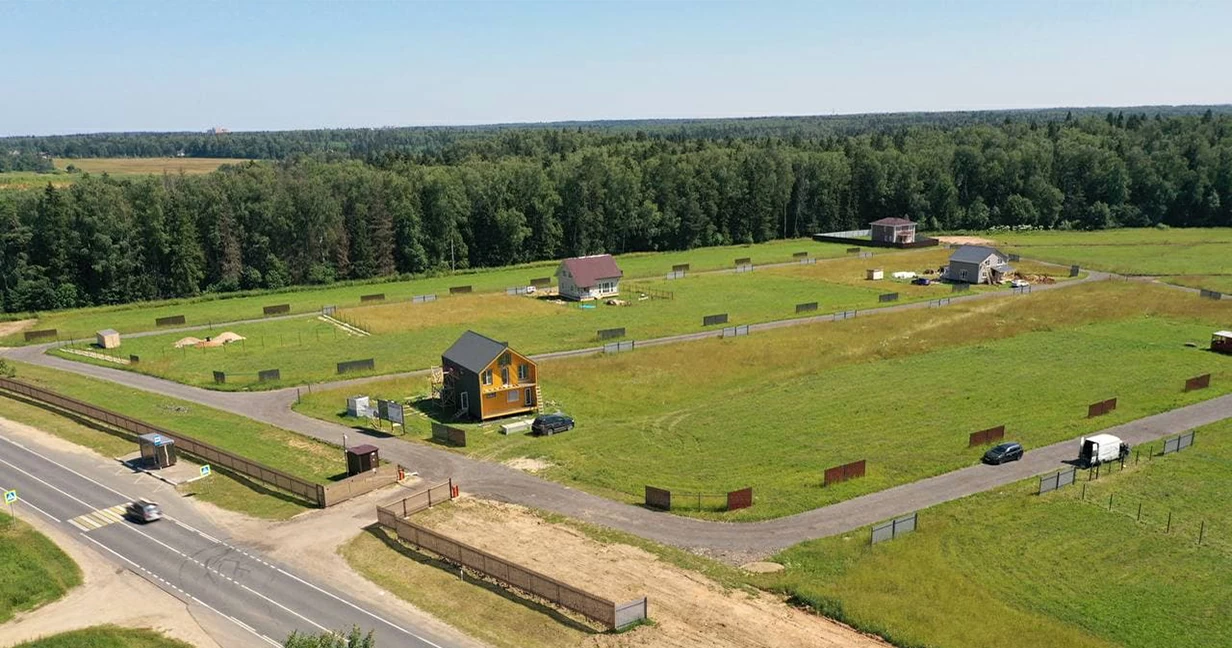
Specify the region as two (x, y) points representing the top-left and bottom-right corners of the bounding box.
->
(423, 499), (887, 648)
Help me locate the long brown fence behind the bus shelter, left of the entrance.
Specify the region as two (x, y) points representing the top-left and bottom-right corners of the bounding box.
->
(0, 378), (325, 506)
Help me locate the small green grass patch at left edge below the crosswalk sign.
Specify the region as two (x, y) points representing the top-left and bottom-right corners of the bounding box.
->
(0, 512), (81, 625)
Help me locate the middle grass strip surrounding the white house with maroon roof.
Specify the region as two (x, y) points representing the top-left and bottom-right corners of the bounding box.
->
(57, 250), (1005, 389)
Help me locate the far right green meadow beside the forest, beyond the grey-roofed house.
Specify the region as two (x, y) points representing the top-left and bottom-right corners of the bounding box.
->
(987, 228), (1232, 292)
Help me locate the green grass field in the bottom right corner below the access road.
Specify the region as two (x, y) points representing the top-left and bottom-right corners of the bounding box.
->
(753, 421), (1232, 648)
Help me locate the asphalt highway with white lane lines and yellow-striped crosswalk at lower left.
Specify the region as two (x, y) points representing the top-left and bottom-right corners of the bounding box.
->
(0, 432), (463, 648)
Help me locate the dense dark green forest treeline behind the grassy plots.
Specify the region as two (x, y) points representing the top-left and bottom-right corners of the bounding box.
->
(0, 112), (1232, 312)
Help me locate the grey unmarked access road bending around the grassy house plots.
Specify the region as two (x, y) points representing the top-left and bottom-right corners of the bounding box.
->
(6, 272), (1232, 564)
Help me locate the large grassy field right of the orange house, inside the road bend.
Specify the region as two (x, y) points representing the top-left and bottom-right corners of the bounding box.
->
(299, 282), (1232, 520)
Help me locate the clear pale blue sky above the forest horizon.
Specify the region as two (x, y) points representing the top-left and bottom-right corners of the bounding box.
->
(0, 0), (1232, 134)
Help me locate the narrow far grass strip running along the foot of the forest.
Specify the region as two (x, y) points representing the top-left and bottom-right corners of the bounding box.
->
(0, 239), (897, 346)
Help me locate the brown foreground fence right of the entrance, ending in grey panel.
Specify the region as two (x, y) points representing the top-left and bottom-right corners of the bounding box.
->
(377, 482), (647, 630)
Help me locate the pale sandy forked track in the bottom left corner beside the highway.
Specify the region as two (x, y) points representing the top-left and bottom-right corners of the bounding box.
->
(0, 514), (226, 648)
